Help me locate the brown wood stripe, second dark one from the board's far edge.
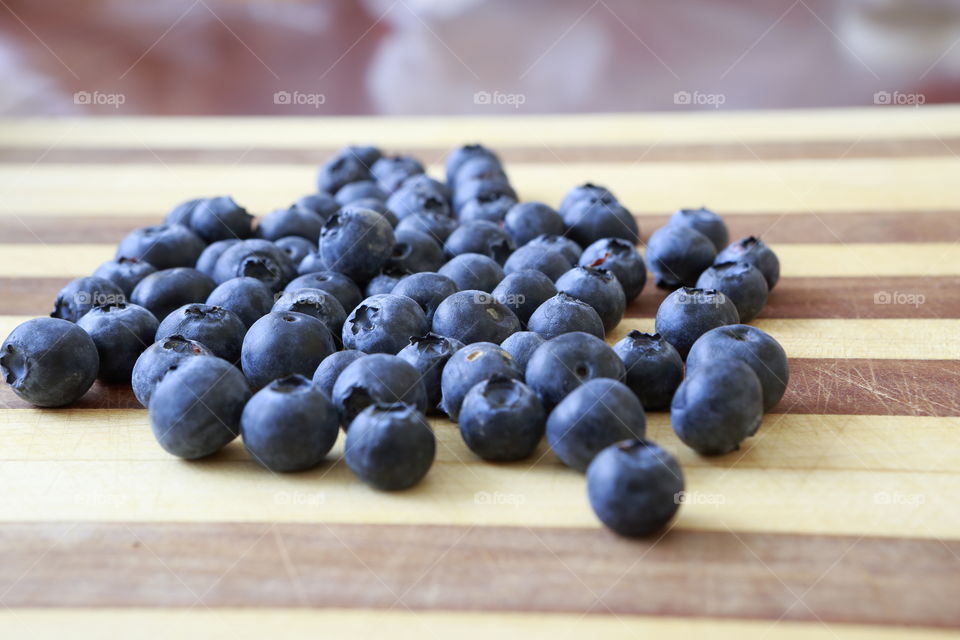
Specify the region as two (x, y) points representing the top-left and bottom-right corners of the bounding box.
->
(0, 211), (960, 244)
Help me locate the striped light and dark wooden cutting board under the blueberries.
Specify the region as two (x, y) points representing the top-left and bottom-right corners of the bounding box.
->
(0, 107), (960, 640)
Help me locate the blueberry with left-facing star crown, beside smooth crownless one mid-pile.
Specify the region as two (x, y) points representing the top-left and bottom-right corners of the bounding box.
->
(343, 294), (429, 354)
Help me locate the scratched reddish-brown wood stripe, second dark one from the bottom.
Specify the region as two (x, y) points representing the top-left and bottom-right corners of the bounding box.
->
(0, 358), (960, 417)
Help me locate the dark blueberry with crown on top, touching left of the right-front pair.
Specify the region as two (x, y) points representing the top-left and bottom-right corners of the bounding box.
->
(613, 331), (683, 411)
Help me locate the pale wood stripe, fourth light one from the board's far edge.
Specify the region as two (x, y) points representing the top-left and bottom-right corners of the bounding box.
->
(0, 316), (960, 360)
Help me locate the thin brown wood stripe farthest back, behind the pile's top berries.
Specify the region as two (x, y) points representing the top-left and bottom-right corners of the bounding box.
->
(0, 138), (960, 164)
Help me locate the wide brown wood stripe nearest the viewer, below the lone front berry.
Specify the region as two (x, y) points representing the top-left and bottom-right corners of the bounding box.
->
(0, 524), (960, 628)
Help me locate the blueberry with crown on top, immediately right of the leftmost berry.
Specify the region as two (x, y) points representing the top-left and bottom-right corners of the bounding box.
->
(77, 302), (159, 382)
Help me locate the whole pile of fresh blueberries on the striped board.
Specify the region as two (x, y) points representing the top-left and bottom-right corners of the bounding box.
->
(0, 145), (788, 535)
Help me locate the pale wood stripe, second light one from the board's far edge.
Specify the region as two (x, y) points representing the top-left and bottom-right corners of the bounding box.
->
(0, 156), (960, 215)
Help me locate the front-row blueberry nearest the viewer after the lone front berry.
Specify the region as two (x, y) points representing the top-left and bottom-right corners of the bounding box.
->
(344, 403), (437, 491)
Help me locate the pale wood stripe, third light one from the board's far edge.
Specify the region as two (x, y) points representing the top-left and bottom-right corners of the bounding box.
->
(0, 242), (960, 278)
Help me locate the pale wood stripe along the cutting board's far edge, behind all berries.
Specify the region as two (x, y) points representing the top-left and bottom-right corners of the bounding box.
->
(0, 105), (960, 149)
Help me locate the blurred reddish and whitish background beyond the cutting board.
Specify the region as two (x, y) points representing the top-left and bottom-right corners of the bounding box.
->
(0, 0), (960, 115)
